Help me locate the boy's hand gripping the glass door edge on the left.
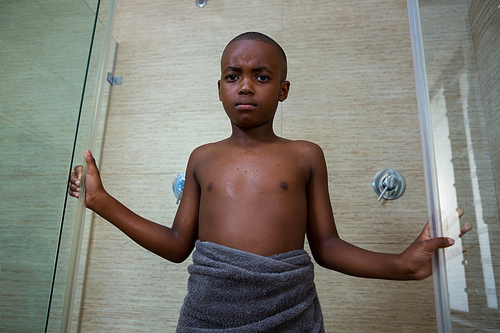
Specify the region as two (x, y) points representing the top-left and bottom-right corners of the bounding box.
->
(68, 150), (106, 209)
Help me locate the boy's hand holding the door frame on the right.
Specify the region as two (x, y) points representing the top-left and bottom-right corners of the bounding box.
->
(401, 208), (472, 280)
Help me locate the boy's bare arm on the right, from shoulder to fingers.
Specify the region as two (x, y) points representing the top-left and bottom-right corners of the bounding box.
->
(307, 144), (472, 280)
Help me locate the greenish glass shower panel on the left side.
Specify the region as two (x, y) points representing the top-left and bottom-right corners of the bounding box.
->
(0, 0), (113, 332)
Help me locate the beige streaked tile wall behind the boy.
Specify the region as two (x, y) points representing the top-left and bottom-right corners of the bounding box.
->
(81, 0), (436, 332)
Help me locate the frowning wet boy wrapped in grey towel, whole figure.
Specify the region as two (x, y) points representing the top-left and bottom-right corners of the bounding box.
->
(69, 32), (471, 332)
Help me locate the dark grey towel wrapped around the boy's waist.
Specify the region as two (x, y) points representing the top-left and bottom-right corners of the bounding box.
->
(177, 241), (324, 333)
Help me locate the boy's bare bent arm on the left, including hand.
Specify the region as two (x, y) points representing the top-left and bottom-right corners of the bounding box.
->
(69, 151), (200, 262)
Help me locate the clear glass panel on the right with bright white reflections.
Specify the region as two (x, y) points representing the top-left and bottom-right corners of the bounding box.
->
(420, 0), (500, 332)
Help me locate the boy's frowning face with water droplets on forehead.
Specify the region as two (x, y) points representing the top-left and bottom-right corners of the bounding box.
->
(219, 40), (290, 128)
